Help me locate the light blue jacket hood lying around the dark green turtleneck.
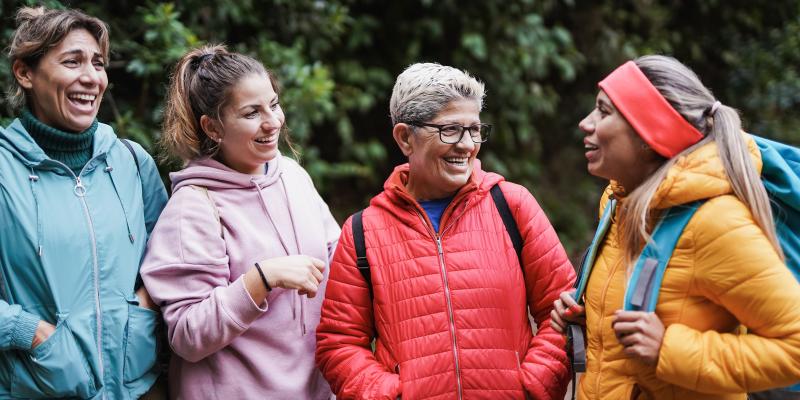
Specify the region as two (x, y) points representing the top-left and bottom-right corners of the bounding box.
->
(0, 118), (117, 168)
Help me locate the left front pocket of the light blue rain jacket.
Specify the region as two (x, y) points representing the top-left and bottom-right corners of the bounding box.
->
(11, 314), (97, 399)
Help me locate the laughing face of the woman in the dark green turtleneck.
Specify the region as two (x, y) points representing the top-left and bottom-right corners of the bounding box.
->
(13, 29), (108, 132)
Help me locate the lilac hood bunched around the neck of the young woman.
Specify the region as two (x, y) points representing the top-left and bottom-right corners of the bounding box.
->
(169, 154), (283, 192)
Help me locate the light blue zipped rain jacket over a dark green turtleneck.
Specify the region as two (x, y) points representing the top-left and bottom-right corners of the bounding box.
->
(0, 120), (167, 399)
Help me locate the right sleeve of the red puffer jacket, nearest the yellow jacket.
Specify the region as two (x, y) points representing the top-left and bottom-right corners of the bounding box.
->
(501, 183), (575, 400)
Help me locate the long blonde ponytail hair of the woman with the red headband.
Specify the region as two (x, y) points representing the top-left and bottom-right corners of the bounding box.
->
(620, 55), (783, 270)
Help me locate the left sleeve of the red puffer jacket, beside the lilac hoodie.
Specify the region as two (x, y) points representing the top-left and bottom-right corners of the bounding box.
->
(316, 219), (401, 400)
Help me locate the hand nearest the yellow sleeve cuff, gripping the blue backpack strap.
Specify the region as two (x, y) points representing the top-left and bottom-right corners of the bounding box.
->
(611, 310), (664, 365)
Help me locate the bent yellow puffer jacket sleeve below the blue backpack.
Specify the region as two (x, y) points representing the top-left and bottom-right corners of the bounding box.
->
(656, 196), (800, 393)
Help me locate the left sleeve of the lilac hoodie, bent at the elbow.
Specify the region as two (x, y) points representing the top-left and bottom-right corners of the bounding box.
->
(141, 187), (266, 362)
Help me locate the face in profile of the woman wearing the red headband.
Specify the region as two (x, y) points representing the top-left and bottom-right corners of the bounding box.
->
(578, 90), (664, 192)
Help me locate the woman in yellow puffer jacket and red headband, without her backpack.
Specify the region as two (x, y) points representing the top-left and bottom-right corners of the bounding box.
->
(552, 56), (800, 400)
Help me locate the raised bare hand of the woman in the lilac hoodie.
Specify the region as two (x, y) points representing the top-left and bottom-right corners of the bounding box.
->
(259, 255), (325, 298)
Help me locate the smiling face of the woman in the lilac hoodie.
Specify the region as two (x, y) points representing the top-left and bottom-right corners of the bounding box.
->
(208, 74), (285, 175)
